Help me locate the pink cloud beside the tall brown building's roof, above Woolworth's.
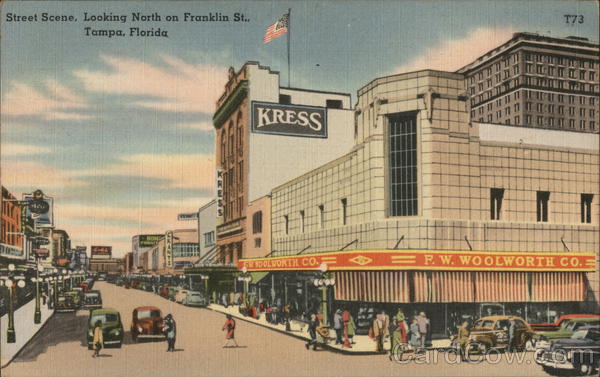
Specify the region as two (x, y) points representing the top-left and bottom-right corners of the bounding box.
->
(394, 27), (513, 73)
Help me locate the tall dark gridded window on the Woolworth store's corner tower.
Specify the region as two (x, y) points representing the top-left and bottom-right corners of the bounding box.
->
(389, 114), (418, 216)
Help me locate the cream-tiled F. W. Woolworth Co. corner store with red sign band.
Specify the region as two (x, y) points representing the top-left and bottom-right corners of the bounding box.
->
(238, 71), (599, 336)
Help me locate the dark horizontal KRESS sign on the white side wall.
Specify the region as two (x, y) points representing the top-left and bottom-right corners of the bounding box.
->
(252, 101), (327, 138)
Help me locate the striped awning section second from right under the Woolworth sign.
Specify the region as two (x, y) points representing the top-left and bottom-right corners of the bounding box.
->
(475, 271), (529, 302)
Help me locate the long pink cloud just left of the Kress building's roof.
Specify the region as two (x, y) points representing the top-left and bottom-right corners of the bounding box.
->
(75, 55), (226, 113)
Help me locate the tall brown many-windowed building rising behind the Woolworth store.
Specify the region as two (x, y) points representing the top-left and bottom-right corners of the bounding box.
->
(458, 33), (600, 133)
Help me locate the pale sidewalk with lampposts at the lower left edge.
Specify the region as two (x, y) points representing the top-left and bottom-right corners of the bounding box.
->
(0, 299), (54, 368)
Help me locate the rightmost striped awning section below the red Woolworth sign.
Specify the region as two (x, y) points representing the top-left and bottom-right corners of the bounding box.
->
(531, 272), (585, 302)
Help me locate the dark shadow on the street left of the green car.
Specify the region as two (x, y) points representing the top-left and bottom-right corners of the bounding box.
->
(13, 310), (88, 363)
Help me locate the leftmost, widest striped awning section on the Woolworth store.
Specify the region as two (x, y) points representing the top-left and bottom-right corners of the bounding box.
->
(334, 271), (410, 303)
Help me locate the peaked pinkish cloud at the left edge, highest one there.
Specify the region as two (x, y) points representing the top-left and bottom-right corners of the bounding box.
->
(2, 80), (90, 120)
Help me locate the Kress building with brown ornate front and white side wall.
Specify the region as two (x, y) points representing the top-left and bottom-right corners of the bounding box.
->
(213, 62), (352, 264)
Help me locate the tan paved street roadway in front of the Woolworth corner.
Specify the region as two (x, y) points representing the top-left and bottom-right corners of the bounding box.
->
(0, 282), (547, 377)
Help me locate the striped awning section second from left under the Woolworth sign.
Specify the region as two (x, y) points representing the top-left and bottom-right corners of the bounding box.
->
(413, 271), (473, 302)
